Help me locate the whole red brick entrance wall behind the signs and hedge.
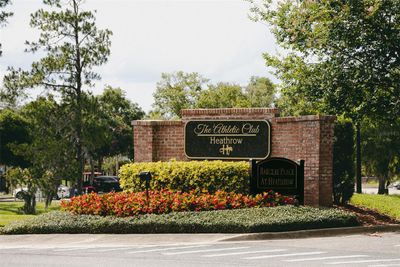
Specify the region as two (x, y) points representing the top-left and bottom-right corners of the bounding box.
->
(132, 108), (335, 206)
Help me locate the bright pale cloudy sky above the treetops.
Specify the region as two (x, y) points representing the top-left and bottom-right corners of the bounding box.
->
(0, 0), (277, 112)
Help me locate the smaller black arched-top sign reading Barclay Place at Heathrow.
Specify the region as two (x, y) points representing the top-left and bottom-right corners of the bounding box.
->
(250, 158), (304, 203)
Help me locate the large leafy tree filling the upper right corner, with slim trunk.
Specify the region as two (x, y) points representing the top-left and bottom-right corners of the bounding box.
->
(250, 0), (400, 192)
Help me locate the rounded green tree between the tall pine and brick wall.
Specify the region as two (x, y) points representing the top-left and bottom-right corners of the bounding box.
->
(82, 86), (144, 178)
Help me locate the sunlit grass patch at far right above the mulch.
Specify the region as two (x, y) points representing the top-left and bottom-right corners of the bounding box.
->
(350, 194), (400, 221)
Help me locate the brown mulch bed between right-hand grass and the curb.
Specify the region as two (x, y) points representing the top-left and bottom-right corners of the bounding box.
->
(336, 204), (400, 226)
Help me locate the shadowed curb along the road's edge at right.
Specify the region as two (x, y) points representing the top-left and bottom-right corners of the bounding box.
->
(218, 224), (400, 242)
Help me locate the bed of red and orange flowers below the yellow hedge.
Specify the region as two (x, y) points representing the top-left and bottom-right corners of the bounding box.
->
(61, 190), (296, 217)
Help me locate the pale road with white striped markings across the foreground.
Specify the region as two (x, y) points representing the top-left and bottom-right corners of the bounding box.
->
(0, 233), (400, 267)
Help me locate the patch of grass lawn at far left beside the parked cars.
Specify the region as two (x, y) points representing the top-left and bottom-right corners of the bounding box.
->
(0, 201), (60, 227)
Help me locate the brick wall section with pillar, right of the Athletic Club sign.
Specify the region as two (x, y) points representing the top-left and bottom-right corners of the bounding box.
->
(271, 116), (336, 206)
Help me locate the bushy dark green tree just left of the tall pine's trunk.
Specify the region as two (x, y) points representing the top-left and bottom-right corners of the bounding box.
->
(18, 96), (78, 207)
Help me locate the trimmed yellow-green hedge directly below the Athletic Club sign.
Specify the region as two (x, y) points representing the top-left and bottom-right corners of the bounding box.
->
(119, 161), (250, 194)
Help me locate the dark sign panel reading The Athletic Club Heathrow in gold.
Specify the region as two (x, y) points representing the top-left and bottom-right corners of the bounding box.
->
(185, 120), (271, 159)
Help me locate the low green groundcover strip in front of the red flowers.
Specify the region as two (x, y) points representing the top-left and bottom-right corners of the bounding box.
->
(0, 206), (359, 234)
